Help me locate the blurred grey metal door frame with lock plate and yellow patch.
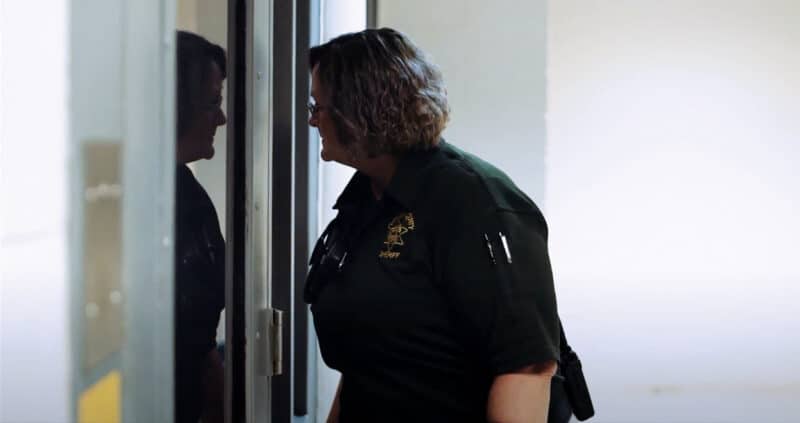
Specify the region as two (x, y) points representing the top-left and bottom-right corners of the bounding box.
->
(69, 0), (176, 422)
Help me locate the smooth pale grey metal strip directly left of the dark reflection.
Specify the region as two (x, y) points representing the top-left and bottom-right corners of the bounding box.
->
(122, 0), (177, 422)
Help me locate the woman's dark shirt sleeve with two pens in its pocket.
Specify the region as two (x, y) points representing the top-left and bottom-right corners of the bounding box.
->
(442, 210), (559, 375)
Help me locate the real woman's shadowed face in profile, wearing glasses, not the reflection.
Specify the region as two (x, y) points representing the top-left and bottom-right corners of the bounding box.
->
(308, 66), (350, 165)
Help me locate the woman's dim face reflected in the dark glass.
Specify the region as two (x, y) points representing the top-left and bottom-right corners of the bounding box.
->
(176, 62), (227, 163)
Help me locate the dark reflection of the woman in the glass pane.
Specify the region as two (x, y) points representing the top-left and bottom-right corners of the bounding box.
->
(175, 31), (225, 423)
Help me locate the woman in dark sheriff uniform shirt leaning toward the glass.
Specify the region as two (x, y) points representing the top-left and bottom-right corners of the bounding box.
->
(306, 29), (559, 422)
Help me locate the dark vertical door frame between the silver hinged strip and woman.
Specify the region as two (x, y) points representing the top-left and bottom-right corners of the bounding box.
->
(271, 0), (320, 423)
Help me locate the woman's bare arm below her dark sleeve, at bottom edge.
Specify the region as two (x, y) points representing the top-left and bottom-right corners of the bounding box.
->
(486, 361), (556, 423)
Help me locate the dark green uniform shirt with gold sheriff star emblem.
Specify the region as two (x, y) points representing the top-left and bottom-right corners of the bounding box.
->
(308, 142), (559, 423)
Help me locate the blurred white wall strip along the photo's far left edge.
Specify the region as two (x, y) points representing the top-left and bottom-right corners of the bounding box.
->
(0, 1), (71, 422)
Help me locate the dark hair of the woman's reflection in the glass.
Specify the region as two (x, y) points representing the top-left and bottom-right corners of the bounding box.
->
(175, 31), (226, 137)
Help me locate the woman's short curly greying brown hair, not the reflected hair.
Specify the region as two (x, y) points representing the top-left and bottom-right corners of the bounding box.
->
(309, 28), (450, 157)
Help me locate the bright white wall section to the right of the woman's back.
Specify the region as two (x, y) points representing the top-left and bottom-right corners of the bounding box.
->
(545, 0), (800, 423)
